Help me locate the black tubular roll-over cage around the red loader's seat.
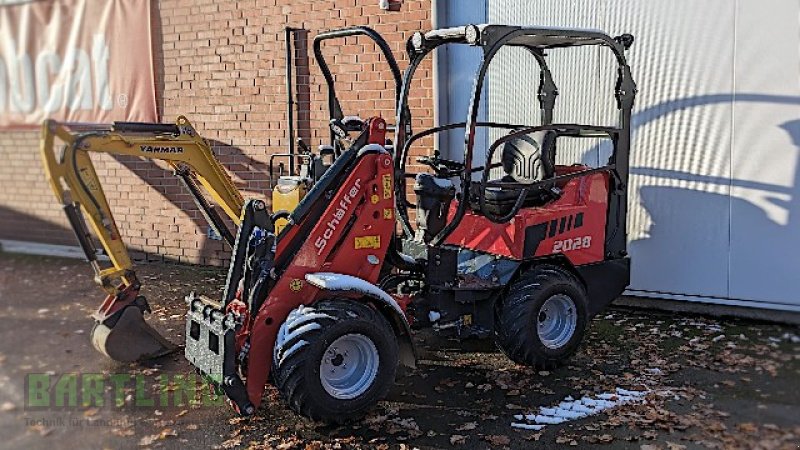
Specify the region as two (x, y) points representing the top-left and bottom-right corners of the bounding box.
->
(395, 25), (636, 258)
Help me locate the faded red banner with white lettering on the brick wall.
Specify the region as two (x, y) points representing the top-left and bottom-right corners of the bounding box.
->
(0, 0), (158, 129)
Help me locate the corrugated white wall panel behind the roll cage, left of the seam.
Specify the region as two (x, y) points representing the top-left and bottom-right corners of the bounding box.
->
(489, 0), (734, 297)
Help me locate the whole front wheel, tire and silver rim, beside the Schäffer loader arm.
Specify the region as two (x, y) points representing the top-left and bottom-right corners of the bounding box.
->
(273, 300), (398, 423)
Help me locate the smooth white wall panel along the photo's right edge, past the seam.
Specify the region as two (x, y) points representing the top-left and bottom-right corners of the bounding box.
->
(730, 0), (800, 306)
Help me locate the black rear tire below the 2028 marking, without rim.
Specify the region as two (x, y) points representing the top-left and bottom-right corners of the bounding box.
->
(495, 264), (587, 370)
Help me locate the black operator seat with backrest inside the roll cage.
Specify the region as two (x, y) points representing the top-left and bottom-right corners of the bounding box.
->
(470, 130), (557, 215)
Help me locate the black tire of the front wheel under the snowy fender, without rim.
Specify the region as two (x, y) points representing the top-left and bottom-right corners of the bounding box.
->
(272, 299), (398, 424)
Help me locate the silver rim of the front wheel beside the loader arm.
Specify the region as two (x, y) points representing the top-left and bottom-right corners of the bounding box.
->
(319, 334), (380, 400)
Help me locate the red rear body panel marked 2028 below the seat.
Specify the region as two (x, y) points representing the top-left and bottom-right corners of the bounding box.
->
(445, 167), (609, 265)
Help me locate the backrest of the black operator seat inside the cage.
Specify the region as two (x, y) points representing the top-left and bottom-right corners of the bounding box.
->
(501, 130), (557, 183)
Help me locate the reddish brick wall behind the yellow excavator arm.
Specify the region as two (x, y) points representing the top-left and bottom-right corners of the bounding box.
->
(0, 0), (433, 264)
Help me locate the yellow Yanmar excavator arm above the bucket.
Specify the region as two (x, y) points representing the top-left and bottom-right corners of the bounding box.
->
(41, 116), (244, 296)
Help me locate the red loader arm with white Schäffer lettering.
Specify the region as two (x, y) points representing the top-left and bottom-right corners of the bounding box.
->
(243, 149), (395, 407)
